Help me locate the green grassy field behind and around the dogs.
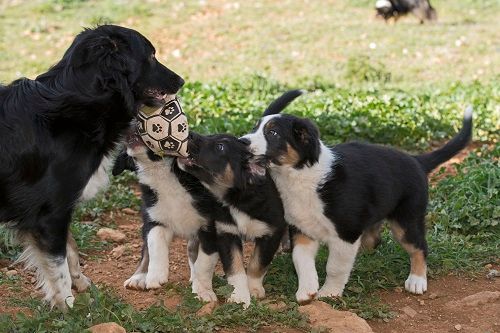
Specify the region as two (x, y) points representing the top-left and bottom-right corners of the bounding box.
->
(0, 0), (500, 332)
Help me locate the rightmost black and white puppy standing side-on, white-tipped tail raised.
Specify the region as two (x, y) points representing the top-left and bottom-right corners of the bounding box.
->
(243, 90), (472, 302)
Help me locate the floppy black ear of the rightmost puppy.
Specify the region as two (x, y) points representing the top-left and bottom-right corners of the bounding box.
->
(292, 118), (321, 168)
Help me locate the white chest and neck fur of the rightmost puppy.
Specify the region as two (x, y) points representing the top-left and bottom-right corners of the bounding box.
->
(271, 144), (338, 242)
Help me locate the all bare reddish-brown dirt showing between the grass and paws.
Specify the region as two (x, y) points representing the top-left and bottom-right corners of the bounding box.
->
(0, 145), (500, 333)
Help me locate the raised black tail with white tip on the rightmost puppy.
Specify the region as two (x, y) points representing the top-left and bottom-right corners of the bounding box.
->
(415, 106), (472, 173)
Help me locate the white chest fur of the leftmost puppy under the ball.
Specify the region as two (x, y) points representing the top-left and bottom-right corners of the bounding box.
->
(137, 159), (205, 238)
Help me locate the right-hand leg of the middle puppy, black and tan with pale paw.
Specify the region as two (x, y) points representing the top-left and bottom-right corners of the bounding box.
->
(247, 228), (283, 298)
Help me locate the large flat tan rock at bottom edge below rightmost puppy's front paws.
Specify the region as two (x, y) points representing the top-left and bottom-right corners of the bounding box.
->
(299, 301), (373, 333)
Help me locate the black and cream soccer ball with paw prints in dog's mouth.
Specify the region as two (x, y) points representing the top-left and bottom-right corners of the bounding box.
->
(137, 98), (189, 157)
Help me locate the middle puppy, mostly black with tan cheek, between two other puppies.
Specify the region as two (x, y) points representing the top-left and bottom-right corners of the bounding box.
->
(178, 133), (286, 307)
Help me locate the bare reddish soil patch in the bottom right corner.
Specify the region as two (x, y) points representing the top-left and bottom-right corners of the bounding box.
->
(368, 267), (500, 333)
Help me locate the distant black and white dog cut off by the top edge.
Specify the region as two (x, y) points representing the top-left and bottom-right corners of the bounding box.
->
(375, 0), (437, 24)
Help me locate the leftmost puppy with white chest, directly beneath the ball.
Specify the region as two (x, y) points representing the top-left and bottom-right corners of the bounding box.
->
(113, 134), (227, 302)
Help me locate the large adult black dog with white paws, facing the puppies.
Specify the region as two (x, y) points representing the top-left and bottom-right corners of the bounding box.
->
(0, 25), (184, 309)
